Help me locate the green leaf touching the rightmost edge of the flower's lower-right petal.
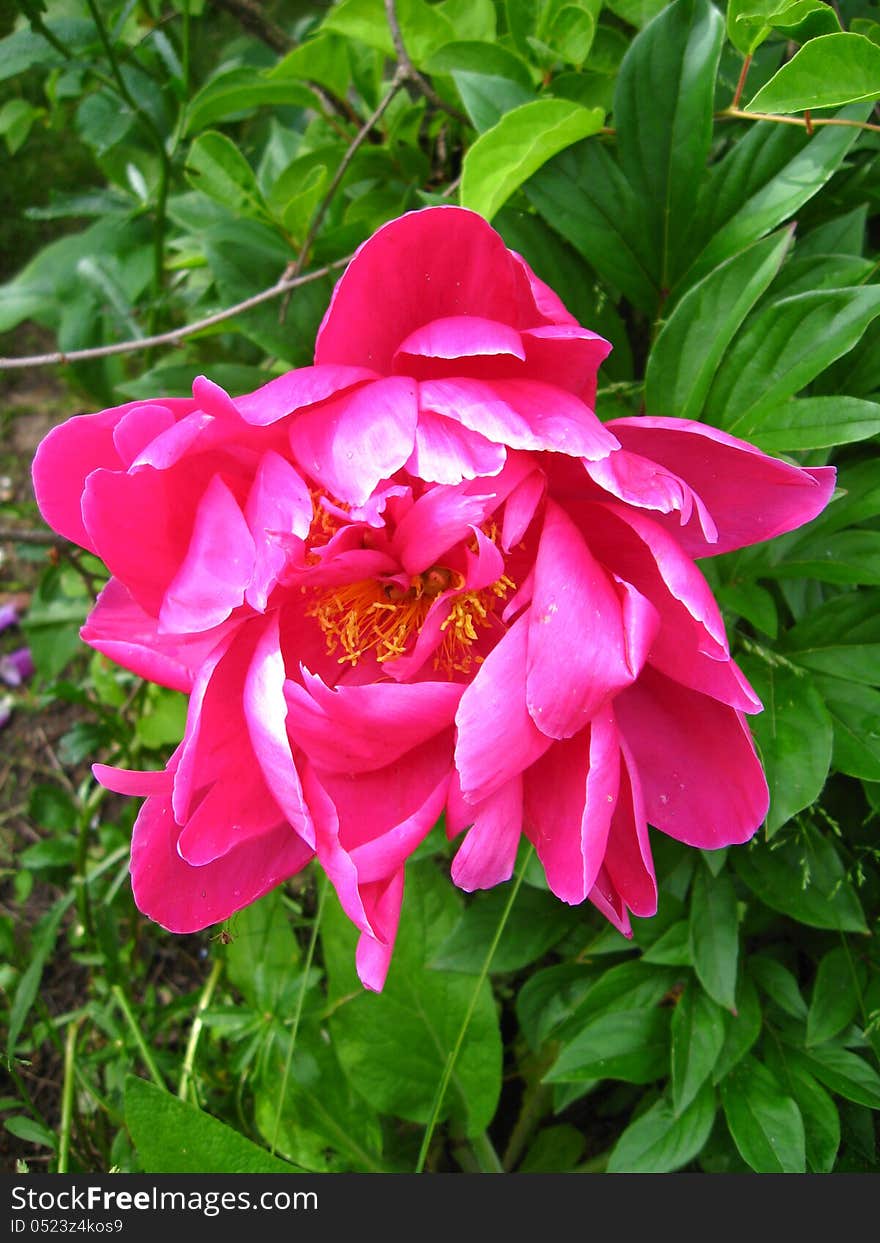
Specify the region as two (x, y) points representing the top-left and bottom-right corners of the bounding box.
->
(741, 656), (833, 837)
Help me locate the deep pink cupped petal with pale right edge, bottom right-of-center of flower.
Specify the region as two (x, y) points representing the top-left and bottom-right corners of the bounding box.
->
(525, 709), (620, 905)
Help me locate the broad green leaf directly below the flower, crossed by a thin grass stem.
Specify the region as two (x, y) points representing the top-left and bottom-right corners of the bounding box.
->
(329, 861), (501, 1135)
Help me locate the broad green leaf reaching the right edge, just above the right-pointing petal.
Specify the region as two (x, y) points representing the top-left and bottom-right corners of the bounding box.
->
(706, 286), (880, 438)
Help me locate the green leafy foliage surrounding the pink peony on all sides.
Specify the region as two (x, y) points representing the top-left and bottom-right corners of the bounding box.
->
(0, 0), (880, 1172)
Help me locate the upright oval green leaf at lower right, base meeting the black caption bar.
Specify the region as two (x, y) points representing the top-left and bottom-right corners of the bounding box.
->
(721, 1058), (807, 1173)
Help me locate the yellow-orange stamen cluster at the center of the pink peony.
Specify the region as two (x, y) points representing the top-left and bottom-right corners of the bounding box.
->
(308, 566), (513, 677)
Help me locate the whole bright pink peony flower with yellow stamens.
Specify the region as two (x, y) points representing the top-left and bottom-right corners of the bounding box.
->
(34, 208), (834, 988)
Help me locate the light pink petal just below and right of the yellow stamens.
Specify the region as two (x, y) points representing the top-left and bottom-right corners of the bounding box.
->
(455, 617), (551, 803)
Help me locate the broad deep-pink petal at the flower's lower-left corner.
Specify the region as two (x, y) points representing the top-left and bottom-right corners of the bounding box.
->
(132, 796), (312, 932)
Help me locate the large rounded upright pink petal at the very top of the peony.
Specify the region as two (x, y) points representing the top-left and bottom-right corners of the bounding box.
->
(314, 206), (522, 374)
